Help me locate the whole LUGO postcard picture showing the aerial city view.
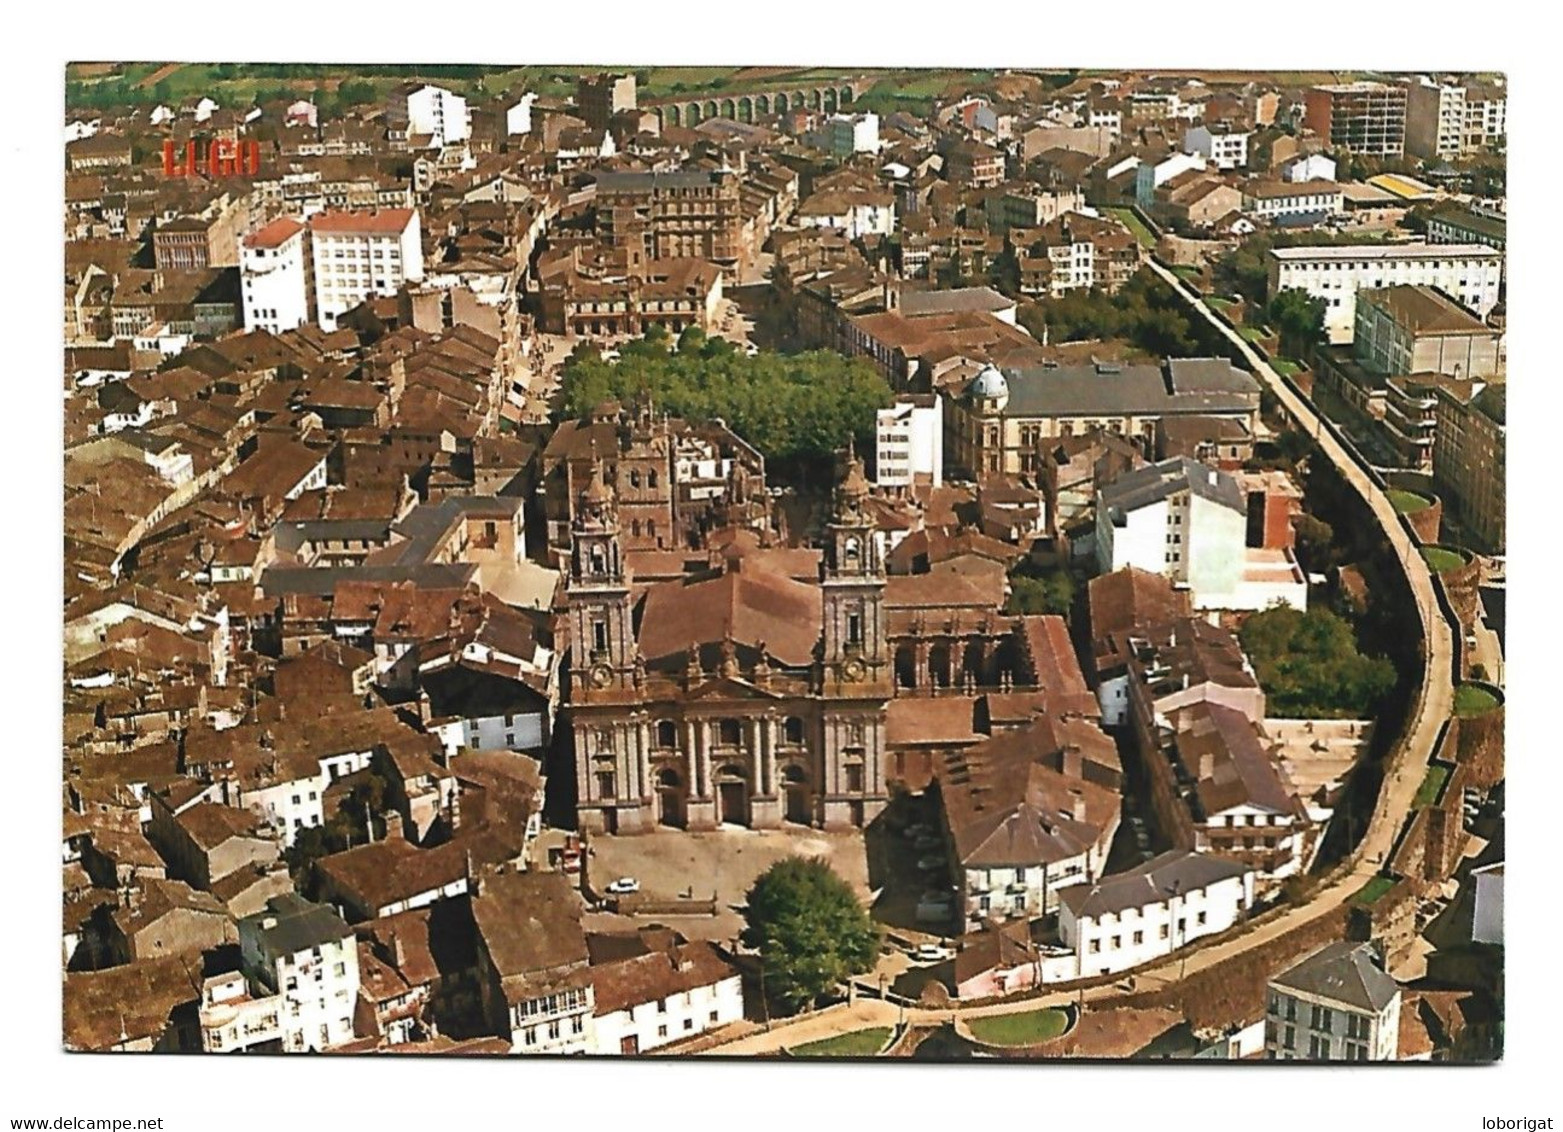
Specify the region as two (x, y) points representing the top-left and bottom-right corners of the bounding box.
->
(50, 63), (1507, 1065)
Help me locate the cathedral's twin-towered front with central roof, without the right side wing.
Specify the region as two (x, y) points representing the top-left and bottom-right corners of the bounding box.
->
(567, 458), (892, 833)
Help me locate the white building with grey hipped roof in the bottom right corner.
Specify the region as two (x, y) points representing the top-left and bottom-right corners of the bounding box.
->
(1264, 941), (1400, 1062)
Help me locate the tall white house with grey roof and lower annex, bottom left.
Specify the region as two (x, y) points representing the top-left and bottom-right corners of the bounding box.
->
(200, 893), (358, 1054)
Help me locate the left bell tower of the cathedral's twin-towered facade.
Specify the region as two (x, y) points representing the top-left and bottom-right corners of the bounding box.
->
(566, 460), (639, 697)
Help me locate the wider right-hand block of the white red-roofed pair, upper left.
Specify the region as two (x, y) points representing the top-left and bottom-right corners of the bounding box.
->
(309, 208), (424, 330)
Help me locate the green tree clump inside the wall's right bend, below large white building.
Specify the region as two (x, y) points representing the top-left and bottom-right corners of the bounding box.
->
(1238, 605), (1394, 719)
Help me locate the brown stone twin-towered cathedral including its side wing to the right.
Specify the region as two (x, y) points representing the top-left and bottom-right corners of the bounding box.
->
(566, 453), (1094, 833)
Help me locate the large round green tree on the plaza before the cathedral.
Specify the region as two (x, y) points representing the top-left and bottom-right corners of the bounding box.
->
(742, 857), (880, 1010)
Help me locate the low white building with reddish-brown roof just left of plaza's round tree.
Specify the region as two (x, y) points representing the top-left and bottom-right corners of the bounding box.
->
(591, 940), (744, 1055)
